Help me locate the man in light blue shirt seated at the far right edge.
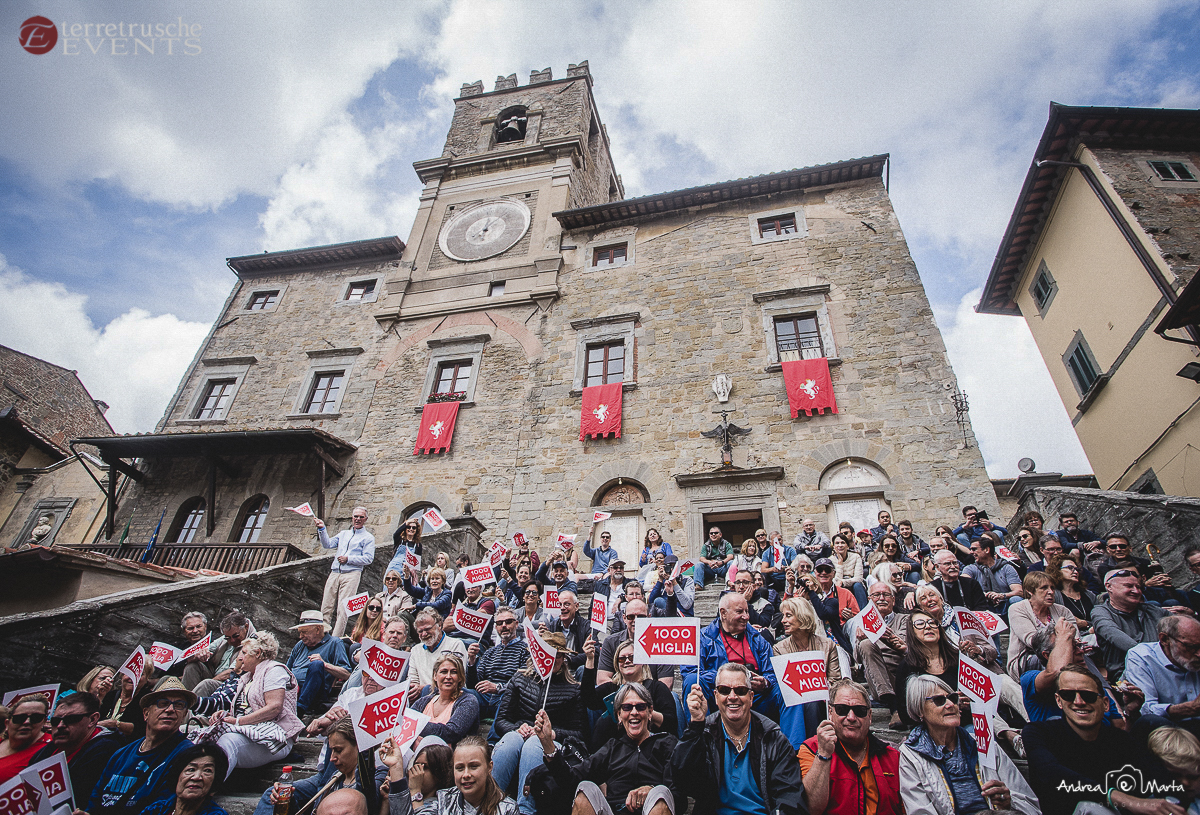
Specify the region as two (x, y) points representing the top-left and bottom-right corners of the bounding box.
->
(1124, 616), (1200, 742)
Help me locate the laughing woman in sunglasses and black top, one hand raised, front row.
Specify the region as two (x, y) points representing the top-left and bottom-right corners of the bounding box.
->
(534, 681), (676, 815)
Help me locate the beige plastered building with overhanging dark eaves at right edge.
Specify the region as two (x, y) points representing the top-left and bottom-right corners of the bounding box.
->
(977, 104), (1200, 496)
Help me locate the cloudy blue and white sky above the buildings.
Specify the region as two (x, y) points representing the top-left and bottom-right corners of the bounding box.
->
(0, 0), (1200, 477)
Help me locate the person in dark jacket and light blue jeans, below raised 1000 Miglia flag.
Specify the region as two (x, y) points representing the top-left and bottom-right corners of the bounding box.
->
(492, 631), (587, 813)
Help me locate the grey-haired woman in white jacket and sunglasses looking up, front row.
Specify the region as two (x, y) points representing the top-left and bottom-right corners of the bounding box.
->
(900, 675), (1042, 815)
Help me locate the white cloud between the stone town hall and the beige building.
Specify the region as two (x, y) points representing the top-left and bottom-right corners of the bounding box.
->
(936, 289), (1092, 478)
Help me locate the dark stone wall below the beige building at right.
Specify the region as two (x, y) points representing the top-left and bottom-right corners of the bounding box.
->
(1009, 487), (1200, 588)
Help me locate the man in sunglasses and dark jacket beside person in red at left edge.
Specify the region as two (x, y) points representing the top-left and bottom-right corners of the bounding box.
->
(30, 693), (125, 803)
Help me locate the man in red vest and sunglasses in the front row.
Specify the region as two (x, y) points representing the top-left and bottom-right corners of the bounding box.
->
(797, 679), (904, 815)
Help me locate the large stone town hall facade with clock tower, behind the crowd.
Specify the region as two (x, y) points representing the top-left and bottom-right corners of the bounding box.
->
(91, 64), (996, 566)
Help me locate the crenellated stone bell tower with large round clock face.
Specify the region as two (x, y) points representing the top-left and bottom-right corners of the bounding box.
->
(376, 61), (624, 323)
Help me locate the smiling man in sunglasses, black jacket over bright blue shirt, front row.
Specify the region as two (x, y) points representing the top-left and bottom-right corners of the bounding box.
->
(671, 662), (805, 815)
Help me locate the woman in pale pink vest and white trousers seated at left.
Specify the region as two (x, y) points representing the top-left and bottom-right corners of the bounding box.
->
(210, 631), (304, 775)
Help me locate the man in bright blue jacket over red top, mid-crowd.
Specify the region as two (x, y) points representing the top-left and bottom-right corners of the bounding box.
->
(680, 592), (784, 720)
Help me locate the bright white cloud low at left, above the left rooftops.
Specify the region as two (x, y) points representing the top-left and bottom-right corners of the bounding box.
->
(0, 256), (209, 433)
